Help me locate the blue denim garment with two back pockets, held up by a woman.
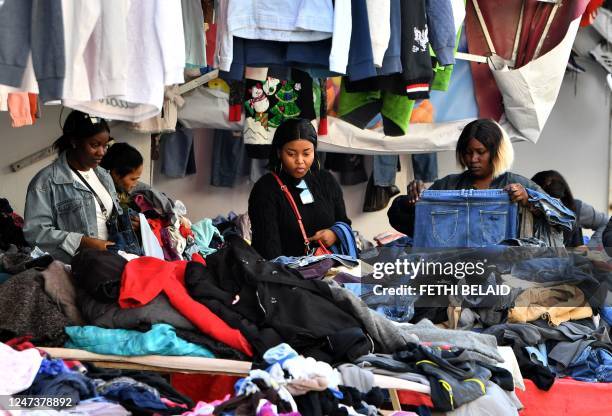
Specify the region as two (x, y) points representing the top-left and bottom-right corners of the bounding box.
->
(414, 189), (518, 247)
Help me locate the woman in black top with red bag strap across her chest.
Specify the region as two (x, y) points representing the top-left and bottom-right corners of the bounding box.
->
(249, 119), (351, 259)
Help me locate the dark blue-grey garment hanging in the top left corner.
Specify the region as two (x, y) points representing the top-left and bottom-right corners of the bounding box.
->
(0, 0), (66, 102)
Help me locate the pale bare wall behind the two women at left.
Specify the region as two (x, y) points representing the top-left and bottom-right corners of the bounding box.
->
(0, 106), (150, 214)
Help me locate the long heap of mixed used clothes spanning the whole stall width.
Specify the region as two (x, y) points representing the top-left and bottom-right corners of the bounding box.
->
(0, 205), (611, 415)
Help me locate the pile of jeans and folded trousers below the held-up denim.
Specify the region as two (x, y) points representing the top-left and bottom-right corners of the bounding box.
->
(361, 238), (612, 390)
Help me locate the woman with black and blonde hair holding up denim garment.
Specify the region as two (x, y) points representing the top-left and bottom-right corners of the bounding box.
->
(387, 119), (575, 247)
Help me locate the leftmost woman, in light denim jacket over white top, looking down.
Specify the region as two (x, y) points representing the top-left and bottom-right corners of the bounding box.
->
(23, 111), (121, 262)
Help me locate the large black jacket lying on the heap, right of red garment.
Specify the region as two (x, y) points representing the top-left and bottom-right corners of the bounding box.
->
(185, 236), (373, 362)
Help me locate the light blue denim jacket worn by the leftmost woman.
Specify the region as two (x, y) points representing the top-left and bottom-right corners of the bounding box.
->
(23, 153), (122, 262)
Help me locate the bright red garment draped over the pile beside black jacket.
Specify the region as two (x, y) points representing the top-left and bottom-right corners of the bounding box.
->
(119, 257), (253, 356)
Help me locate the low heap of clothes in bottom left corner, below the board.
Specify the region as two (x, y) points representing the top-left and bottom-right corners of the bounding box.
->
(0, 337), (194, 416)
